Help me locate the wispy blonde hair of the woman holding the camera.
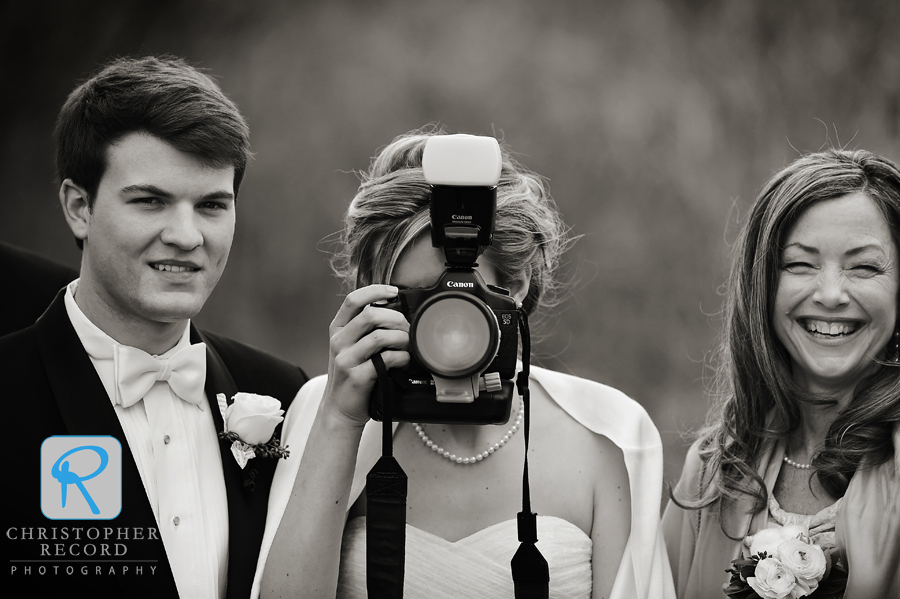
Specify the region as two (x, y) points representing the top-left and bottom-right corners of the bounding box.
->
(332, 130), (569, 315)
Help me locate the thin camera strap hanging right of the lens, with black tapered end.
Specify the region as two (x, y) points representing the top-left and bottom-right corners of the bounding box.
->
(510, 308), (550, 599)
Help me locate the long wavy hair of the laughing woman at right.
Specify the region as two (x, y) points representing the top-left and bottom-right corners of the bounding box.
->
(679, 149), (900, 534)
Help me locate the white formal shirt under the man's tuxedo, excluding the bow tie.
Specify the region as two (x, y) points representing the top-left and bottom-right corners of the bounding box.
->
(65, 279), (228, 599)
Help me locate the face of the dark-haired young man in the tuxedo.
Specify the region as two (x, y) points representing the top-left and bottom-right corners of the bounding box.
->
(76, 132), (235, 332)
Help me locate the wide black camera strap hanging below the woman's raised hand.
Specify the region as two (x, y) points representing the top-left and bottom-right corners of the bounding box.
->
(366, 354), (407, 599)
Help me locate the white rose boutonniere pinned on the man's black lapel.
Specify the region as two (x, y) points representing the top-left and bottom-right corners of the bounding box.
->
(216, 393), (289, 469)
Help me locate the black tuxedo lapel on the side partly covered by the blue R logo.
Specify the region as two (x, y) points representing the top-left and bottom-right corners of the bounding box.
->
(34, 289), (177, 596)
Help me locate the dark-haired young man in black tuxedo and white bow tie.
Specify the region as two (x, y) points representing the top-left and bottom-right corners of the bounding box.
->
(0, 57), (306, 599)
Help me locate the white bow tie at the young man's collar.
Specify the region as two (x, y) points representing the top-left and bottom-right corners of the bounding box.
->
(114, 343), (206, 408)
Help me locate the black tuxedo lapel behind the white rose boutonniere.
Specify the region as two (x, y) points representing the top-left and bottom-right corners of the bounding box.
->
(191, 325), (269, 597)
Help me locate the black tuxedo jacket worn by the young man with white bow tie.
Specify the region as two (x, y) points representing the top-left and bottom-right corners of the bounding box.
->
(0, 291), (307, 599)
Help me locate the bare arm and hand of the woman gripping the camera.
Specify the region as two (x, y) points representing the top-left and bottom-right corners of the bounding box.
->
(260, 285), (409, 598)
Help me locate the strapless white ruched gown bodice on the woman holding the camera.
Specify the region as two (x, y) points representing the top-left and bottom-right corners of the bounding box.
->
(337, 516), (592, 599)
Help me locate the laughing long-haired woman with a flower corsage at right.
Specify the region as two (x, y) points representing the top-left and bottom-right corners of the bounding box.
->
(663, 150), (900, 599)
